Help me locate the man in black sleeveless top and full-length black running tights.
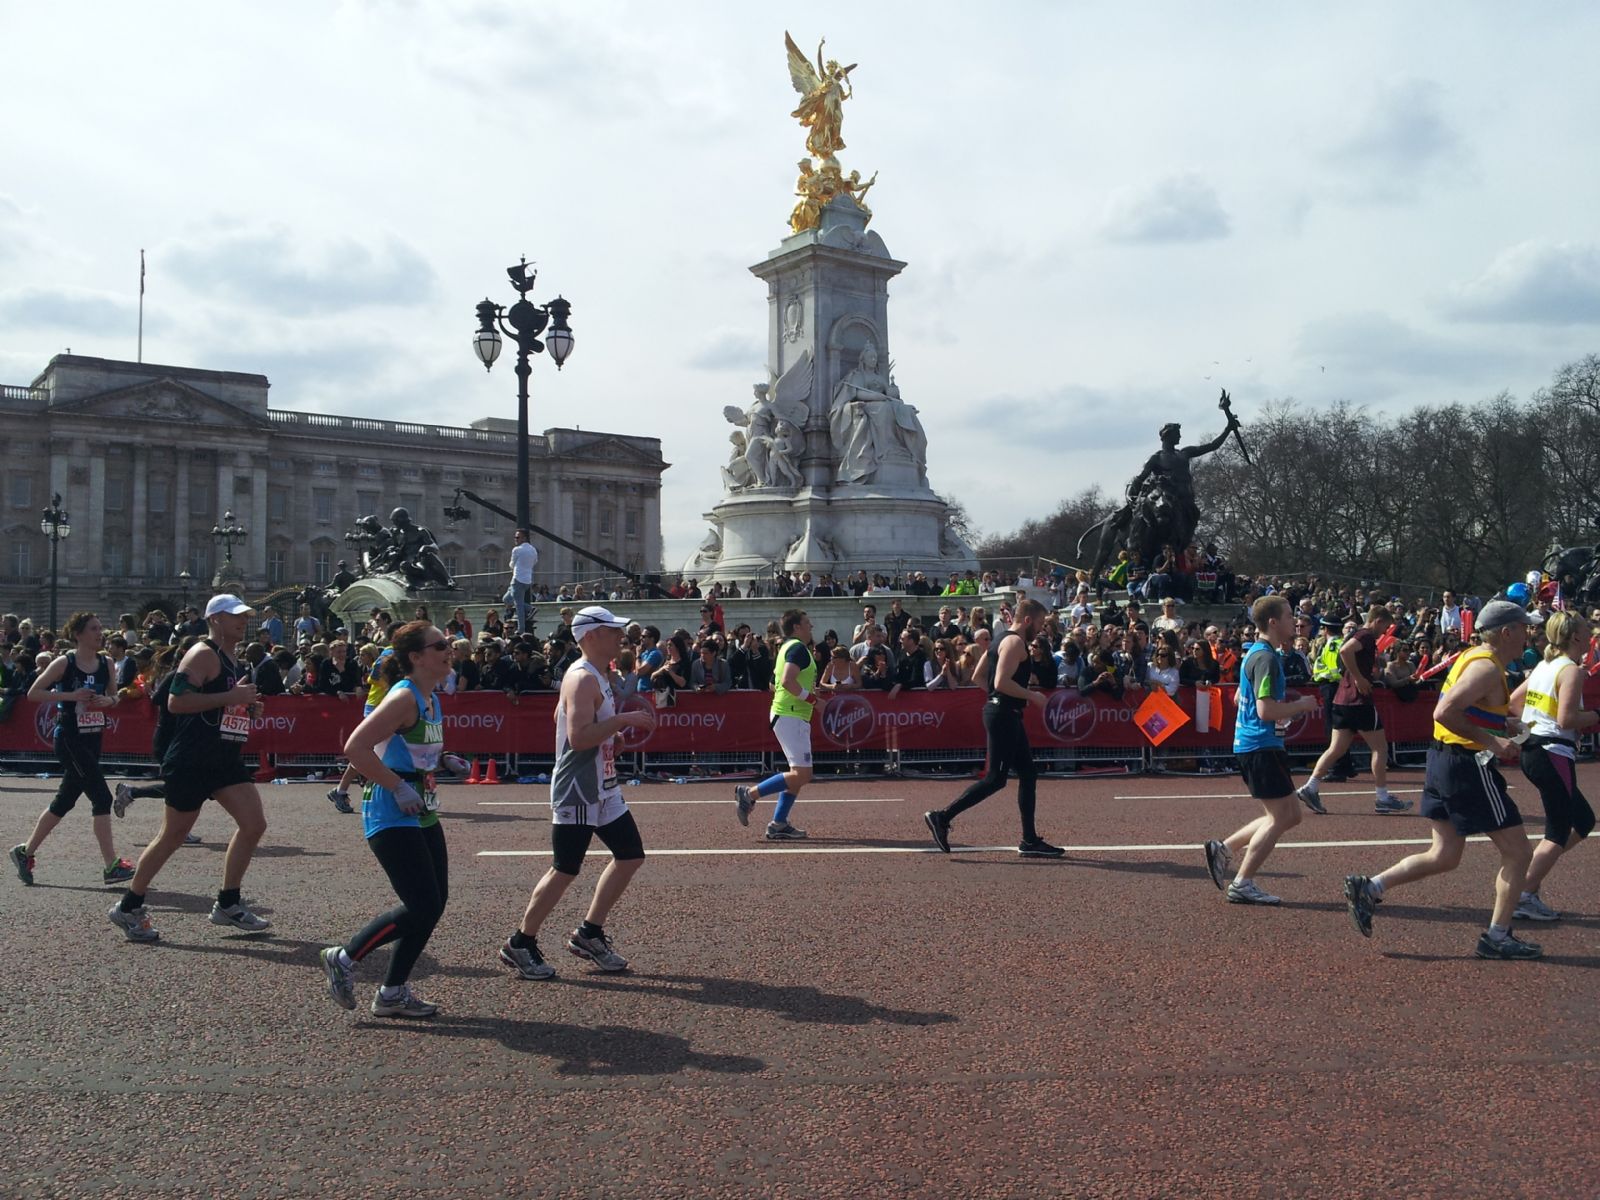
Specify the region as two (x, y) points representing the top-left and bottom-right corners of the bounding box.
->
(922, 600), (1067, 858)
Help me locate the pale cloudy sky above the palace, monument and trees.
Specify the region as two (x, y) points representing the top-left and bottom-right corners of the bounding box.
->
(0, 0), (1600, 570)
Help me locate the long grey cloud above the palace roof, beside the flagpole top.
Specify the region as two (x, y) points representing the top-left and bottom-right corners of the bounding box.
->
(164, 227), (437, 315)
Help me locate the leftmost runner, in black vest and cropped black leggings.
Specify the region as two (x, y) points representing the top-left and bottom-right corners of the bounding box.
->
(11, 613), (133, 883)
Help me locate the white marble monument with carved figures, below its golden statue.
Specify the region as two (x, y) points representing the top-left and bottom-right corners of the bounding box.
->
(683, 192), (978, 584)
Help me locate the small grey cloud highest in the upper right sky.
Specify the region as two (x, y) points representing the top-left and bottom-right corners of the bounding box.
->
(1325, 78), (1466, 203)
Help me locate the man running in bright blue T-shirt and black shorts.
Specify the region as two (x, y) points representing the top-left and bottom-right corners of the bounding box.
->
(1205, 595), (1318, 904)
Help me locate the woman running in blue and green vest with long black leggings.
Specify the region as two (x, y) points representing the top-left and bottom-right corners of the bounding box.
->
(322, 621), (461, 1018)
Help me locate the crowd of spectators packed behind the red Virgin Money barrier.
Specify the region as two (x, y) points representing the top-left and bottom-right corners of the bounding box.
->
(0, 560), (1600, 720)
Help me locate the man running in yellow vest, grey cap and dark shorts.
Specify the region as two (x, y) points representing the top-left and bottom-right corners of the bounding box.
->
(1344, 600), (1544, 958)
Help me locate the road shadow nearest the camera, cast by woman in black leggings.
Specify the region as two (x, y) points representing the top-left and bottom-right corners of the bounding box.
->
(390, 1014), (766, 1075)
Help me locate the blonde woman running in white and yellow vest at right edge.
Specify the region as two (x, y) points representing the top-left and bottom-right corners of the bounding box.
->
(1512, 613), (1600, 922)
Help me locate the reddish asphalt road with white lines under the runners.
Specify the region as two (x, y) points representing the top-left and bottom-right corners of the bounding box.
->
(0, 766), (1600, 1200)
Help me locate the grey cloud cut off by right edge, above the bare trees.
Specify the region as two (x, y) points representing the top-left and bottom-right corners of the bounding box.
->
(1443, 240), (1600, 325)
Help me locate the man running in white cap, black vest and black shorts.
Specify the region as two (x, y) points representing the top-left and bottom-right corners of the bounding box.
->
(109, 595), (272, 942)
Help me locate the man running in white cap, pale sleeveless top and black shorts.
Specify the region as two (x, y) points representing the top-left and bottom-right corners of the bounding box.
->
(499, 605), (656, 979)
